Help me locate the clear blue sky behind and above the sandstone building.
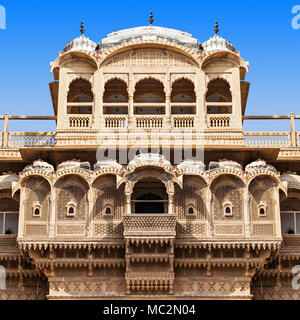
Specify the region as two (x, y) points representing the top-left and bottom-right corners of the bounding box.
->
(0, 0), (300, 131)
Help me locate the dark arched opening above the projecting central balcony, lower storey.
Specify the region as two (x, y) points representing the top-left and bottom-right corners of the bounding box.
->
(132, 178), (168, 214)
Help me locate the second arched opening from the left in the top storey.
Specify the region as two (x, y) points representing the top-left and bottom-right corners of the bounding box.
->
(103, 79), (128, 114)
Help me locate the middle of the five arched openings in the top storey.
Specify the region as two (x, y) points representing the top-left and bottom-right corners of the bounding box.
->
(133, 78), (166, 115)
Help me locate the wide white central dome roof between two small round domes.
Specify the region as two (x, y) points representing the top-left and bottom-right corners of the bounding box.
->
(99, 26), (199, 50)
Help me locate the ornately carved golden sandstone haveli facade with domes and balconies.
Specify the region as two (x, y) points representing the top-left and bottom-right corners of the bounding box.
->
(0, 19), (300, 300)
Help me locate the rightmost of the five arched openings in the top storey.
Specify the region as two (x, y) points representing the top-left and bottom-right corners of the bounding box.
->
(206, 78), (232, 114)
